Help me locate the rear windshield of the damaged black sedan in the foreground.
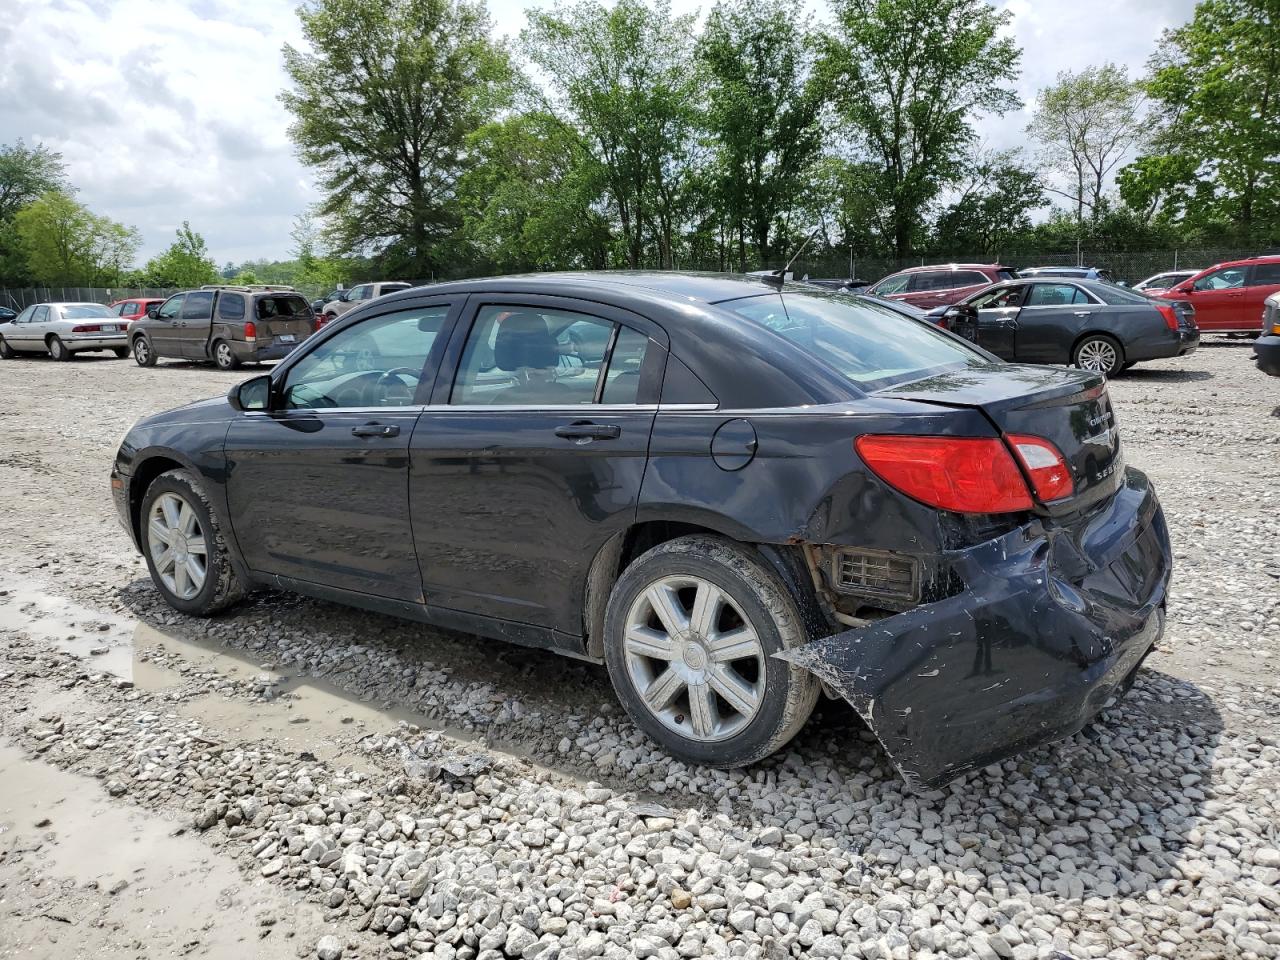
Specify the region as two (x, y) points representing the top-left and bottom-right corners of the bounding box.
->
(718, 293), (992, 390)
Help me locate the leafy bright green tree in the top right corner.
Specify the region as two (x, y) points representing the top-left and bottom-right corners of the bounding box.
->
(1119, 0), (1280, 241)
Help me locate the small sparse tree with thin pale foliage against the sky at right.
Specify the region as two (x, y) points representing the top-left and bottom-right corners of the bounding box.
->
(1027, 63), (1146, 224)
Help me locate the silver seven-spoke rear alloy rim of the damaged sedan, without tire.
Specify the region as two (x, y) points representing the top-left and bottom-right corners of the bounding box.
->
(622, 576), (765, 742)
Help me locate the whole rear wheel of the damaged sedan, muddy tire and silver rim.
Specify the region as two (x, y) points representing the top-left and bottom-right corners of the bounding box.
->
(604, 535), (820, 767)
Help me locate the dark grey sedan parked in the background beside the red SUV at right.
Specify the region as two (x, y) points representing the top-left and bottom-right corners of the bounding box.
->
(931, 279), (1199, 376)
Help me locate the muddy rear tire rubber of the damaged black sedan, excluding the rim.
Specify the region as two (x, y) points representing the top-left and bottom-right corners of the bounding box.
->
(604, 535), (822, 768)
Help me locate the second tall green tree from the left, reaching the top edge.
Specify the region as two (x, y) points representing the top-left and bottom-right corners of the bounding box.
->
(521, 0), (699, 268)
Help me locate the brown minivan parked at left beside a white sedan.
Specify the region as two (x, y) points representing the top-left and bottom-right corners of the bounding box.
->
(129, 285), (316, 370)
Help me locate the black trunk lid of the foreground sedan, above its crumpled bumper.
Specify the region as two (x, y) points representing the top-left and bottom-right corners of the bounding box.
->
(877, 364), (1124, 513)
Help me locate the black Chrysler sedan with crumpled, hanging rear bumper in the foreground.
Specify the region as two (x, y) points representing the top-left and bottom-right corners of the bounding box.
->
(111, 273), (1170, 786)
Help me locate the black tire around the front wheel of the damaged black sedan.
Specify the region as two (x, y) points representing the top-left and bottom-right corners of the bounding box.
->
(138, 470), (244, 617)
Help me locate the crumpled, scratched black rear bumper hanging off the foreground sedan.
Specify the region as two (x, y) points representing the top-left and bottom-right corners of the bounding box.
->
(778, 470), (1172, 788)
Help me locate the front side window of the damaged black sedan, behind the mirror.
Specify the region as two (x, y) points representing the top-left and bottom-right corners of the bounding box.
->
(283, 303), (449, 410)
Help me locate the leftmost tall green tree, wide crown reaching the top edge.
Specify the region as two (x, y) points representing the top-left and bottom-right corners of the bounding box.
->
(280, 0), (511, 276)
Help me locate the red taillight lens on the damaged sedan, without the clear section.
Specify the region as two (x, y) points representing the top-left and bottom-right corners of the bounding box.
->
(854, 435), (1033, 513)
